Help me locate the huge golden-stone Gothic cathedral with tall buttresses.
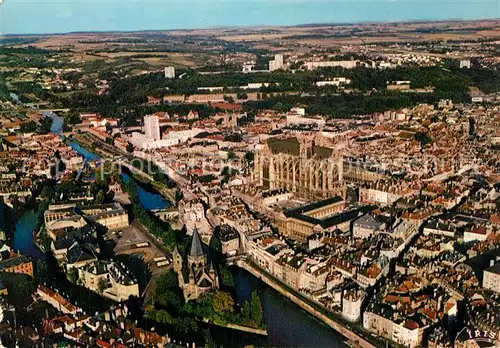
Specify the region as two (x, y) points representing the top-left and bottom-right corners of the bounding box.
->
(254, 137), (345, 200)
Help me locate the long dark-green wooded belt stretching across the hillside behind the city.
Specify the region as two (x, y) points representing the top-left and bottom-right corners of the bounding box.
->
(56, 61), (500, 125)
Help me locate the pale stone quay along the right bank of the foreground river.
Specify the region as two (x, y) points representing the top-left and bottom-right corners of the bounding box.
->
(236, 260), (377, 348)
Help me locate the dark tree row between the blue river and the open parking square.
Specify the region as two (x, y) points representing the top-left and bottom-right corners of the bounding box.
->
(125, 179), (176, 249)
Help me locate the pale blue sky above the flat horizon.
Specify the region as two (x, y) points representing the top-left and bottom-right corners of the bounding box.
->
(0, 0), (500, 34)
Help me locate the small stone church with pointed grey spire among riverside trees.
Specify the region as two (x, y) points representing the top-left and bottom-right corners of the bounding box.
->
(173, 229), (219, 302)
